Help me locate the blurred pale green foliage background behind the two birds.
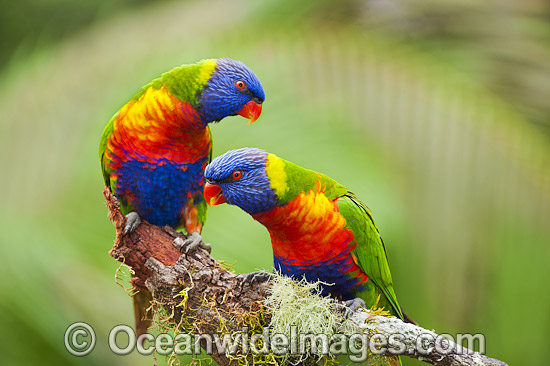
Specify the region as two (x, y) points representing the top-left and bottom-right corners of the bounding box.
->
(0, 0), (550, 365)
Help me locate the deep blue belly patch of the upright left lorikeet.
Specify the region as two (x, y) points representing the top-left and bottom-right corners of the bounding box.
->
(114, 157), (208, 228)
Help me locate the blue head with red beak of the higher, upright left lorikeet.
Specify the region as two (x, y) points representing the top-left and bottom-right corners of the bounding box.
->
(198, 58), (265, 123)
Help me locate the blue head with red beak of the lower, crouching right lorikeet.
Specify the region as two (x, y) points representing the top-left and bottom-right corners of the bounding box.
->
(204, 147), (279, 215)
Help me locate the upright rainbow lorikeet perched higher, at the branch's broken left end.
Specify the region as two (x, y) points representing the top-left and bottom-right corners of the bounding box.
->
(99, 58), (265, 334)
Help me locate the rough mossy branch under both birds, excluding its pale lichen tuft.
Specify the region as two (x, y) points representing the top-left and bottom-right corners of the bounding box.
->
(103, 189), (506, 366)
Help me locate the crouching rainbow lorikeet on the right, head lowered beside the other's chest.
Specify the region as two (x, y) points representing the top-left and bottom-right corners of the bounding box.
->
(204, 148), (409, 320)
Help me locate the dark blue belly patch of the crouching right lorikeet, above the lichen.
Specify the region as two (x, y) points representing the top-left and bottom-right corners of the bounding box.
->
(273, 256), (372, 300)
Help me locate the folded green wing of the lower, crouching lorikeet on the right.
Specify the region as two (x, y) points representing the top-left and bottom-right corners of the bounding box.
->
(337, 191), (403, 319)
